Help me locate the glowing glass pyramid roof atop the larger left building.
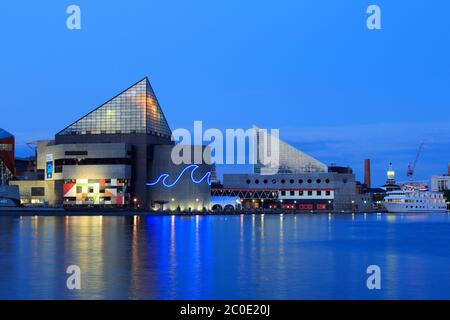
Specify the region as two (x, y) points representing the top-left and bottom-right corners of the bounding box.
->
(58, 78), (172, 138)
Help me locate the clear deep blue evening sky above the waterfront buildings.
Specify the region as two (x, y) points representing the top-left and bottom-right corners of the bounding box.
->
(0, 0), (450, 184)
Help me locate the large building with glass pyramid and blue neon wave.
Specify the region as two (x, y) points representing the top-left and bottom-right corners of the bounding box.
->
(10, 78), (211, 210)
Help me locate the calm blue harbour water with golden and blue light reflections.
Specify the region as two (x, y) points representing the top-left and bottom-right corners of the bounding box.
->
(0, 214), (450, 299)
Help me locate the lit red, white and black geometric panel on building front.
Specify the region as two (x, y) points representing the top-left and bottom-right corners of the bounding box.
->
(63, 179), (130, 206)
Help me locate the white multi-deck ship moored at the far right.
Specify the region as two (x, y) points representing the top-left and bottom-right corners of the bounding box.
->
(384, 186), (447, 213)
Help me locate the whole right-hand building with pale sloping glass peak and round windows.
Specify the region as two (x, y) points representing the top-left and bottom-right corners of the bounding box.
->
(211, 129), (373, 212)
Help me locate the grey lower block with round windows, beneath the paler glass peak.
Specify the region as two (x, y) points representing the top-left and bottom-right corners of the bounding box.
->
(212, 168), (373, 211)
